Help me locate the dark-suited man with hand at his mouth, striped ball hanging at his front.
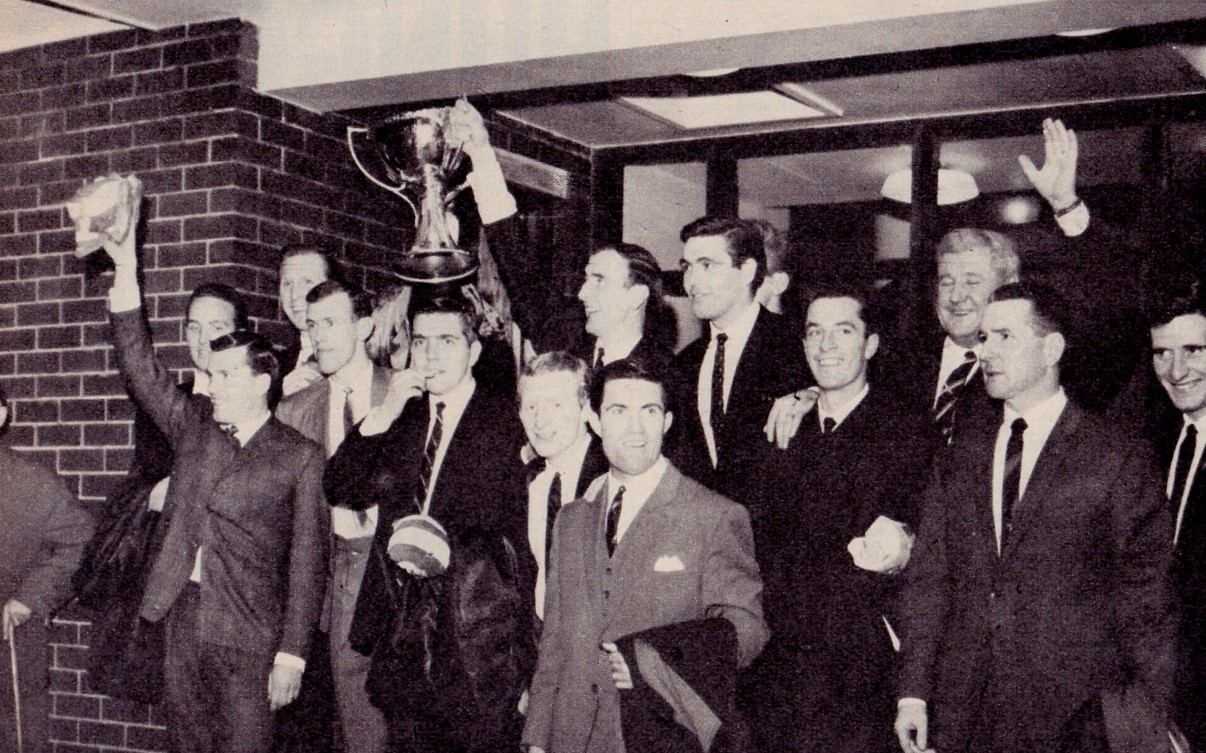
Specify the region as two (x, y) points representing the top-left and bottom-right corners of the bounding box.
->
(326, 298), (534, 753)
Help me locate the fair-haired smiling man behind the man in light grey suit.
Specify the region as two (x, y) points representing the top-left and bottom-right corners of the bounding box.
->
(520, 350), (608, 619)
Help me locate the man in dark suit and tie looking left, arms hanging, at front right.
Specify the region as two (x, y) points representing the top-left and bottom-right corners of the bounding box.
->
(895, 282), (1176, 753)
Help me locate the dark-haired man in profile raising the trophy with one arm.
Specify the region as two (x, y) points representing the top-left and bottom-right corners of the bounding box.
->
(453, 100), (675, 368)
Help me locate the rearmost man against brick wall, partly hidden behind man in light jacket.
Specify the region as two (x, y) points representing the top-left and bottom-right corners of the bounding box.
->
(279, 244), (341, 395)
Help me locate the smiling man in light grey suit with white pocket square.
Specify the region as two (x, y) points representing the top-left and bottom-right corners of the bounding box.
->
(523, 361), (768, 753)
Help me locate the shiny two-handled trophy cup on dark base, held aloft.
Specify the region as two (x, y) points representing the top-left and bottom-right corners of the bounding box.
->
(347, 107), (478, 285)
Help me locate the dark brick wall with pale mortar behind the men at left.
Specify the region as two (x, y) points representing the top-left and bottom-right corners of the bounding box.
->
(0, 22), (411, 751)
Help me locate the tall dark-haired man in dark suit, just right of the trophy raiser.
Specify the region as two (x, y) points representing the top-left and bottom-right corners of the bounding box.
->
(671, 217), (807, 503)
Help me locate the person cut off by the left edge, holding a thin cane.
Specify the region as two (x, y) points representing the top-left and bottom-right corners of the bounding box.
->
(0, 387), (92, 753)
